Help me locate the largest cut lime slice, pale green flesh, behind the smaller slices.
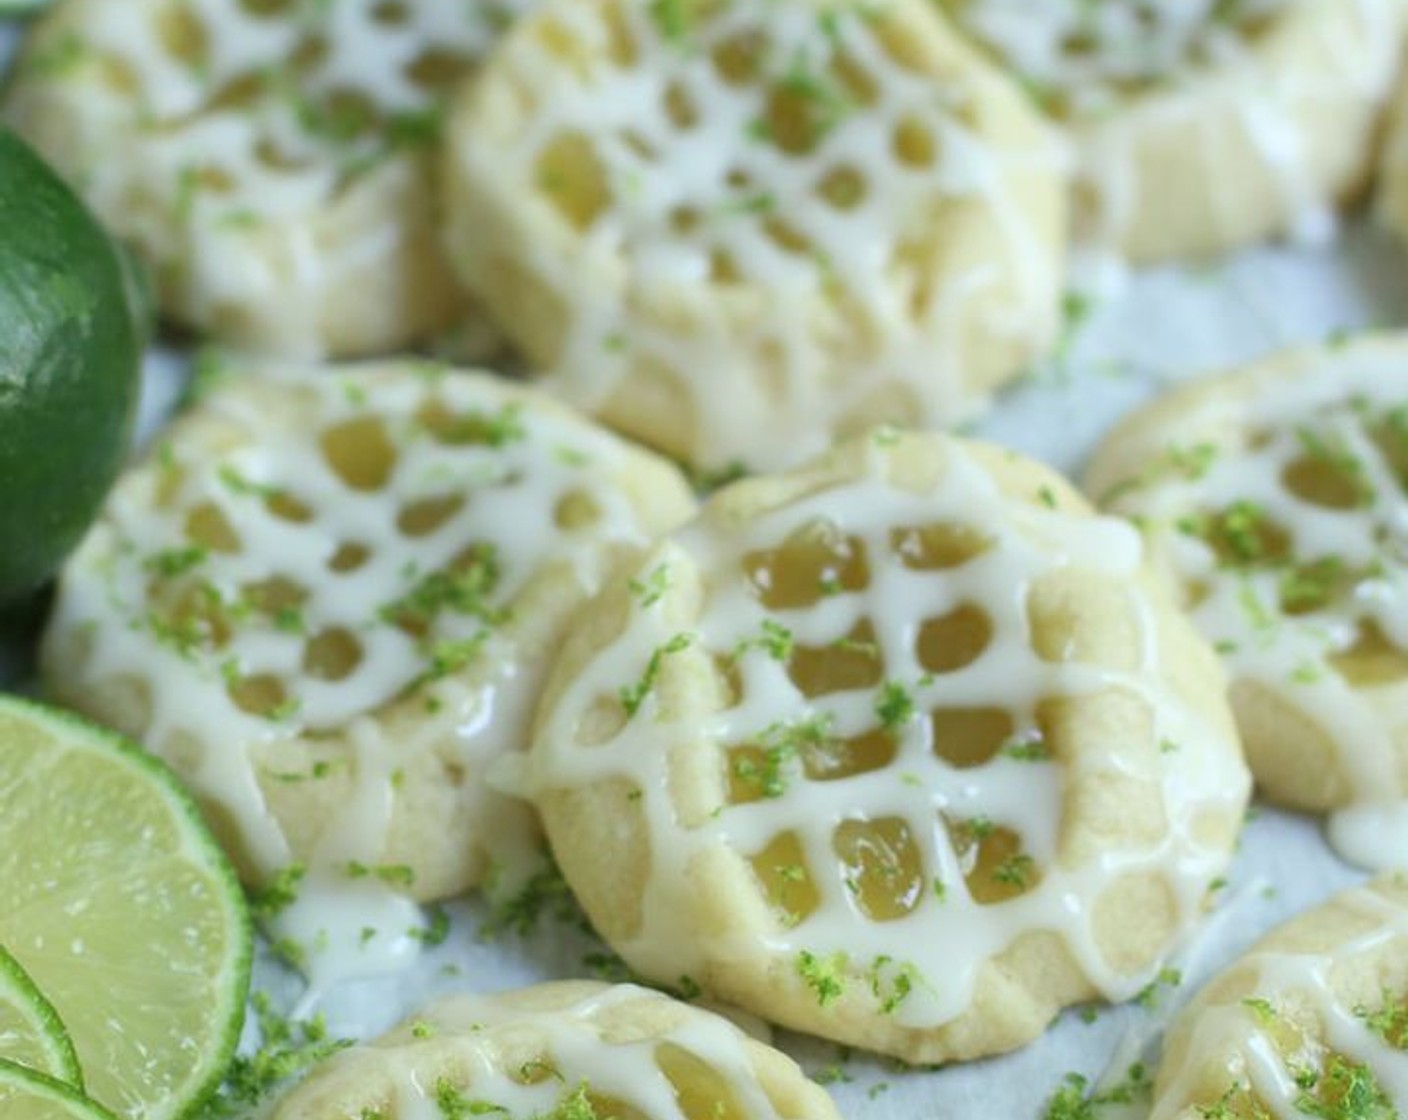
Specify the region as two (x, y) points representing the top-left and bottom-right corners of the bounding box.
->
(0, 696), (251, 1120)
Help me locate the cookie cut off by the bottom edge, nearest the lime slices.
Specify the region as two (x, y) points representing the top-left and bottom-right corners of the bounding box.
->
(269, 981), (839, 1120)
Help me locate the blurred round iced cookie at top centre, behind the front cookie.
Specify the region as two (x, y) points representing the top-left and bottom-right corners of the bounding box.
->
(446, 0), (1064, 469)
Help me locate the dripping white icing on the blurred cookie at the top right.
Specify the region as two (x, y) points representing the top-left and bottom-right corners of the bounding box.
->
(946, 0), (1402, 247)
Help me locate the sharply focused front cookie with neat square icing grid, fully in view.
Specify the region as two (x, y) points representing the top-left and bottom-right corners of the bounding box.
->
(527, 430), (1249, 1062)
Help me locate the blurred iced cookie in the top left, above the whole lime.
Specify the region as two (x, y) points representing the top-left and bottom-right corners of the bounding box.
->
(4, 0), (529, 358)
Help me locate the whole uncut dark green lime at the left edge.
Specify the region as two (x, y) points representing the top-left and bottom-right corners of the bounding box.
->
(0, 130), (145, 602)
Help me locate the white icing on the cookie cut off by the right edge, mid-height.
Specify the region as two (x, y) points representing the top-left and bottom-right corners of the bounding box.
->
(1111, 344), (1408, 868)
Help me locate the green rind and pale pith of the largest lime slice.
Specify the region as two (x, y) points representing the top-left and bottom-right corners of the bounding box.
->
(0, 696), (253, 1120)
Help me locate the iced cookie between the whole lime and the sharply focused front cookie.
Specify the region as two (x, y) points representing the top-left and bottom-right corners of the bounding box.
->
(42, 362), (694, 980)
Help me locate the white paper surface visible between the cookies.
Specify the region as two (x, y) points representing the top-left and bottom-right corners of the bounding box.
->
(0, 17), (1408, 1120)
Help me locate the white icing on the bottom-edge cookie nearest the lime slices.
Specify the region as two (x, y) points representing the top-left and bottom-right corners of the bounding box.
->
(273, 983), (832, 1120)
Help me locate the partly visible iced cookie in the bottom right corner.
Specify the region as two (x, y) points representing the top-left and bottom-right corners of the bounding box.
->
(1152, 876), (1408, 1120)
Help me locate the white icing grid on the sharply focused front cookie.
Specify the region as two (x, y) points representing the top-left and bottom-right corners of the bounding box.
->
(531, 445), (1247, 1028)
